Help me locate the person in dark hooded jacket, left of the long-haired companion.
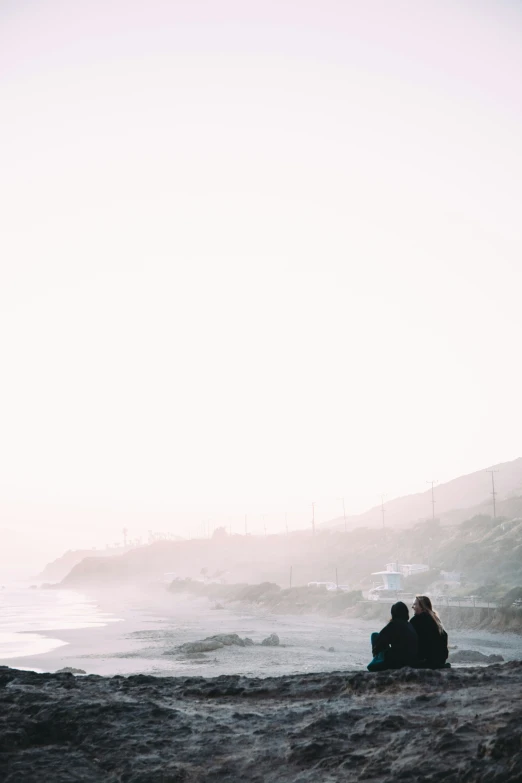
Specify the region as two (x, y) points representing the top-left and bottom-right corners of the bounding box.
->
(368, 601), (418, 672)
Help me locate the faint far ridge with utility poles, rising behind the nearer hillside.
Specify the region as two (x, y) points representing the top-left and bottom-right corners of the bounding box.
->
(320, 457), (522, 530)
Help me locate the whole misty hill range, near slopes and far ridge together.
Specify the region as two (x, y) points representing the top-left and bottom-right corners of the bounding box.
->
(53, 458), (522, 592)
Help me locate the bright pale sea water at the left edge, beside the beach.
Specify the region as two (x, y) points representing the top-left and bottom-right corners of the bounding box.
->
(0, 583), (118, 664)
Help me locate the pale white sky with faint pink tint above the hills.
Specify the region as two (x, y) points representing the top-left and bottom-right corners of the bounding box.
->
(0, 0), (522, 545)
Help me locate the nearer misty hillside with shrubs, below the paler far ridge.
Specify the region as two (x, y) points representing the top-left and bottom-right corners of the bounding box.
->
(62, 515), (522, 598)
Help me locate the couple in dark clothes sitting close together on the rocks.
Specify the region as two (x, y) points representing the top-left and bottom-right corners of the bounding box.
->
(368, 595), (449, 672)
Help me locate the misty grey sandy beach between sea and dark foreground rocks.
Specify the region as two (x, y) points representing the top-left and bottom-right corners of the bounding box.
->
(4, 585), (522, 677)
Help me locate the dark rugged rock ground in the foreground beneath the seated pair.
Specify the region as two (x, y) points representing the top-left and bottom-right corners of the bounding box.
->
(0, 662), (522, 783)
